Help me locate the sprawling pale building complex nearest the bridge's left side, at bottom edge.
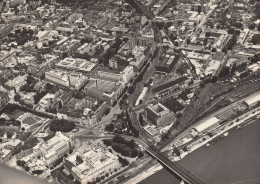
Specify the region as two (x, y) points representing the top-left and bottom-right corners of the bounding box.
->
(64, 145), (121, 184)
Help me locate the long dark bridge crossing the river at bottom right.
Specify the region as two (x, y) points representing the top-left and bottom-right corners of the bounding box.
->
(146, 146), (204, 184)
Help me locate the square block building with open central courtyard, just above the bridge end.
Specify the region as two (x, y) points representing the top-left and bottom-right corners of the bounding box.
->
(145, 103), (175, 126)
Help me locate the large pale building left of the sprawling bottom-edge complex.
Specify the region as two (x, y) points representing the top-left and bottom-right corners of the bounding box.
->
(33, 132), (74, 166)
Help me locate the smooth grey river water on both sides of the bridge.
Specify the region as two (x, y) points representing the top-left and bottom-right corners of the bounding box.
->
(140, 119), (260, 184)
